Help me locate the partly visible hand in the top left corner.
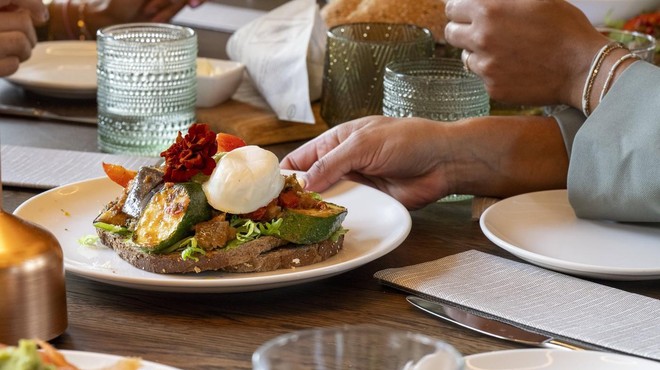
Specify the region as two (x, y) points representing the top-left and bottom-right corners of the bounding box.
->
(0, 0), (48, 76)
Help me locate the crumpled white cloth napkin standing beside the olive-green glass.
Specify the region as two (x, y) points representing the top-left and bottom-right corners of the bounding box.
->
(227, 0), (327, 124)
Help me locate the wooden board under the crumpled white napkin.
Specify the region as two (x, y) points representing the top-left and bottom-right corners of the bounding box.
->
(197, 78), (328, 145)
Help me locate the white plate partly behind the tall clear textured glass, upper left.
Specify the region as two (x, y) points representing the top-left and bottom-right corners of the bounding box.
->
(7, 41), (96, 99)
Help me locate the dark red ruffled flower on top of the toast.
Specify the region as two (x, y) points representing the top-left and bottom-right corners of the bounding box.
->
(160, 123), (218, 182)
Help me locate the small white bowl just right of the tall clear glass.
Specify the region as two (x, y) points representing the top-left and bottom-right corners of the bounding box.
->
(196, 58), (245, 108)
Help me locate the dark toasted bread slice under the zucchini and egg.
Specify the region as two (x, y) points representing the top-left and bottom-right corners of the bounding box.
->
(97, 229), (344, 274)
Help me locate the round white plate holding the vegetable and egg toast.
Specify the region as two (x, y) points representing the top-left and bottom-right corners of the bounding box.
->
(14, 173), (411, 292)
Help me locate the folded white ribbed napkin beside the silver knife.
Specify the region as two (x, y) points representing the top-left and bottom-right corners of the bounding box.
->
(374, 250), (660, 360)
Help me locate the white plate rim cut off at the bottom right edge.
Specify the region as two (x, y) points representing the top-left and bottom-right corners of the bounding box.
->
(465, 348), (660, 370)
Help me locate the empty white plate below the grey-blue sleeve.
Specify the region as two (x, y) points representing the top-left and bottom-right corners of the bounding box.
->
(480, 190), (660, 280)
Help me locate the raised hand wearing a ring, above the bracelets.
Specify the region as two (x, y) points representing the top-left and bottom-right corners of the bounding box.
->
(445, 0), (608, 108)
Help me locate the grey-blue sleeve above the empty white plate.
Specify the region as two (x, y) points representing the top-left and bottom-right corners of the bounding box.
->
(568, 62), (660, 222)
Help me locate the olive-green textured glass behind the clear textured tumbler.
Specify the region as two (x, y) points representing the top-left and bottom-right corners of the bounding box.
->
(321, 23), (435, 126)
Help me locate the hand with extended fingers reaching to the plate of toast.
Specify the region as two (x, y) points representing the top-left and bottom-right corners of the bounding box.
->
(281, 116), (451, 209)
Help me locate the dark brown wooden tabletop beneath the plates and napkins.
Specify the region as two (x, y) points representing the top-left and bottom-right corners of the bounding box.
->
(0, 13), (660, 370)
